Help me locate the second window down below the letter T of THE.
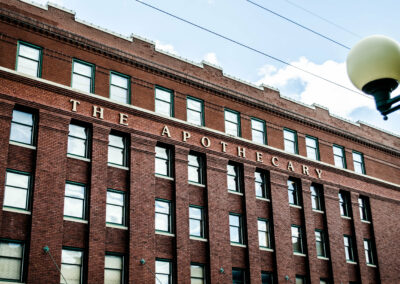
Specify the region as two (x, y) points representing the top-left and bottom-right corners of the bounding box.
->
(64, 182), (86, 219)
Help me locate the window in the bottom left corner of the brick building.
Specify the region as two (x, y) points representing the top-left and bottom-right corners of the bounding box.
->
(0, 240), (24, 282)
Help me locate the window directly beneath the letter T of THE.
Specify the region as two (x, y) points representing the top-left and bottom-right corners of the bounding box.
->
(68, 123), (89, 158)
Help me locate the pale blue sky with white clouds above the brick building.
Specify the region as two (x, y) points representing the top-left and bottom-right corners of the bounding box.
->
(30, 0), (400, 135)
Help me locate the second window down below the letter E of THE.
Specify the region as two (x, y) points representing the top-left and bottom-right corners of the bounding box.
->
(106, 189), (125, 225)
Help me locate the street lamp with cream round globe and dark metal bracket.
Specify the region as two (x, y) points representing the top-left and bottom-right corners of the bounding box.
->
(347, 35), (400, 120)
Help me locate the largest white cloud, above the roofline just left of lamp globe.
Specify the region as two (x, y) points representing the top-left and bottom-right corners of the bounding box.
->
(256, 57), (375, 118)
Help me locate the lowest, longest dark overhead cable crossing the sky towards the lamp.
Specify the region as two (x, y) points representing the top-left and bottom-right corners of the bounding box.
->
(135, 0), (372, 99)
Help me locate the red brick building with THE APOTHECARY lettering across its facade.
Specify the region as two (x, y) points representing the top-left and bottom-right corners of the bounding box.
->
(0, 0), (400, 284)
